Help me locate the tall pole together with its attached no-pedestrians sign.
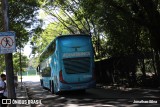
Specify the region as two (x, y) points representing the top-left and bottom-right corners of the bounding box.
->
(0, 0), (16, 107)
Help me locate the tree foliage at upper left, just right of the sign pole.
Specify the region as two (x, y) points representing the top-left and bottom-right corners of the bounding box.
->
(0, 0), (41, 72)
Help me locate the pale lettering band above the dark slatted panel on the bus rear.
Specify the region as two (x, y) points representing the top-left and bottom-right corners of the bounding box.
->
(63, 52), (90, 58)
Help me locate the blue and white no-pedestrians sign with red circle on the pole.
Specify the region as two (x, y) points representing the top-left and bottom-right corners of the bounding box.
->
(0, 32), (16, 54)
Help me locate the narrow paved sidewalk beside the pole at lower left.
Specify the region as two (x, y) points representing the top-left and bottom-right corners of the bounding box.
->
(16, 83), (31, 107)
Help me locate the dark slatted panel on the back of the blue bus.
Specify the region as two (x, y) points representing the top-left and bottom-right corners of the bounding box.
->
(63, 57), (91, 74)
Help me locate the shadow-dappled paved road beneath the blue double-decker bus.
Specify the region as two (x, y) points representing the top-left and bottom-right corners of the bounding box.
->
(22, 76), (160, 107)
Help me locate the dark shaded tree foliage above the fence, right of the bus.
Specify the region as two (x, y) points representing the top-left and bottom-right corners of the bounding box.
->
(81, 0), (160, 56)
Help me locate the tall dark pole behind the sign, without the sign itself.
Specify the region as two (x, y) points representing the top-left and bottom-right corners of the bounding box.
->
(1, 0), (16, 107)
